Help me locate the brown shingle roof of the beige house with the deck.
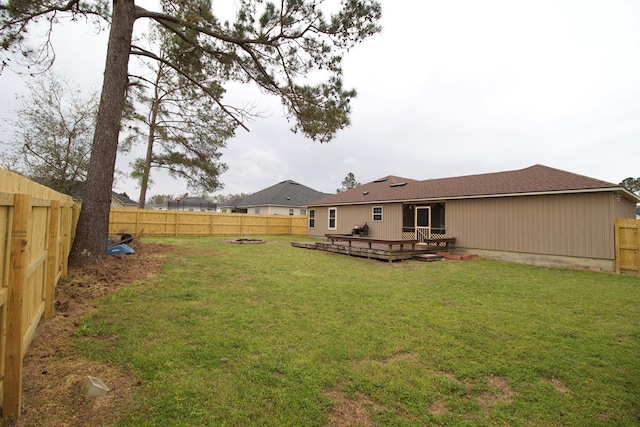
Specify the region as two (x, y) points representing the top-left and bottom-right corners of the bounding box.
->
(310, 165), (637, 206)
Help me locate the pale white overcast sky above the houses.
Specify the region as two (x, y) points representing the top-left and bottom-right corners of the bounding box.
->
(0, 0), (640, 200)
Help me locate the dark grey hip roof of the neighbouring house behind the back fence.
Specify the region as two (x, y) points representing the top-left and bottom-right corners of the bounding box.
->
(234, 180), (328, 208)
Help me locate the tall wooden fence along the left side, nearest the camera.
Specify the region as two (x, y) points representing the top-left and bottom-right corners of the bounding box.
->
(0, 169), (78, 417)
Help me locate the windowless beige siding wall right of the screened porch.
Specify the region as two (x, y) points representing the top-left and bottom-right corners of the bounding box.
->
(446, 193), (614, 259)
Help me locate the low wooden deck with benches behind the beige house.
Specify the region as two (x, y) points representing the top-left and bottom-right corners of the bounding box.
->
(292, 234), (455, 262)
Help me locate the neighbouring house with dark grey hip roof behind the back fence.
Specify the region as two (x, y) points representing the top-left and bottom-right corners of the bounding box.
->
(233, 180), (328, 215)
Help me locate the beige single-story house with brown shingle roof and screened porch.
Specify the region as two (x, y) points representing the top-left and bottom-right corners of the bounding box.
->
(307, 165), (640, 271)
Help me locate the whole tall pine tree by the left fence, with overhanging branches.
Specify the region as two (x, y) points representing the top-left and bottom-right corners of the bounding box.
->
(0, 0), (381, 263)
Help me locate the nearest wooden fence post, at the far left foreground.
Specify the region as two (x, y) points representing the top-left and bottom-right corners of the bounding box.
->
(2, 194), (31, 417)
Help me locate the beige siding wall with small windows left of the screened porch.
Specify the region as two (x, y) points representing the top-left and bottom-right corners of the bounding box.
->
(308, 203), (402, 239)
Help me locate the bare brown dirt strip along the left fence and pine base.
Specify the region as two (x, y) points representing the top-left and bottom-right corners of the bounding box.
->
(2, 241), (177, 427)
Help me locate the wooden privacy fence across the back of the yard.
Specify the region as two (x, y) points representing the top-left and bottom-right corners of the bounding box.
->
(109, 208), (307, 237)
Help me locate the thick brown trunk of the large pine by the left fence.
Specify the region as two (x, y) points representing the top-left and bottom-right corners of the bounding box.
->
(70, 0), (136, 265)
